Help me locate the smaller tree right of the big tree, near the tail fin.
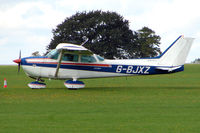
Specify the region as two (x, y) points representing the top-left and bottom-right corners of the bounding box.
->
(135, 27), (161, 58)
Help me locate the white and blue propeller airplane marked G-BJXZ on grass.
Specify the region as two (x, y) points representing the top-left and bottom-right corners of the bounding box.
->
(13, 36), (194, 90)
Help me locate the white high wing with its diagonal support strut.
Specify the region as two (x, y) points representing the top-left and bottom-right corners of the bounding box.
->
(55, 43), (93, 77)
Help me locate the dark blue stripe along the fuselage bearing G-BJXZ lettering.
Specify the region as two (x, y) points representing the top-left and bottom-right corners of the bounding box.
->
(22, 58), (184, 75)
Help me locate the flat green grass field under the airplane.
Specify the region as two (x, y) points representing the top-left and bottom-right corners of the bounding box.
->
(0, 65), (200, 133)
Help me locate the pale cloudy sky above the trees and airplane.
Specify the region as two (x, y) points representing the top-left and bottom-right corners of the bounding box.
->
(0, 0), (200, 65)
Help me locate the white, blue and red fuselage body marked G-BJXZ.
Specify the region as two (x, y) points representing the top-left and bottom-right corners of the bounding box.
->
(21, 54), (183, 79)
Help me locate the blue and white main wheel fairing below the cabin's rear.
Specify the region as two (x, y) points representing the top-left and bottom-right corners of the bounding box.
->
(64, 78), (85, 90)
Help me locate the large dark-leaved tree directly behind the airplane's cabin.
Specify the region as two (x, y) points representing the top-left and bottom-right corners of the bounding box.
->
(47, 11), (162, 59)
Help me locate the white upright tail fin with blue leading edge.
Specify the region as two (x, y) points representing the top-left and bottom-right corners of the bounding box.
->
(158, 36), (194, 67)
